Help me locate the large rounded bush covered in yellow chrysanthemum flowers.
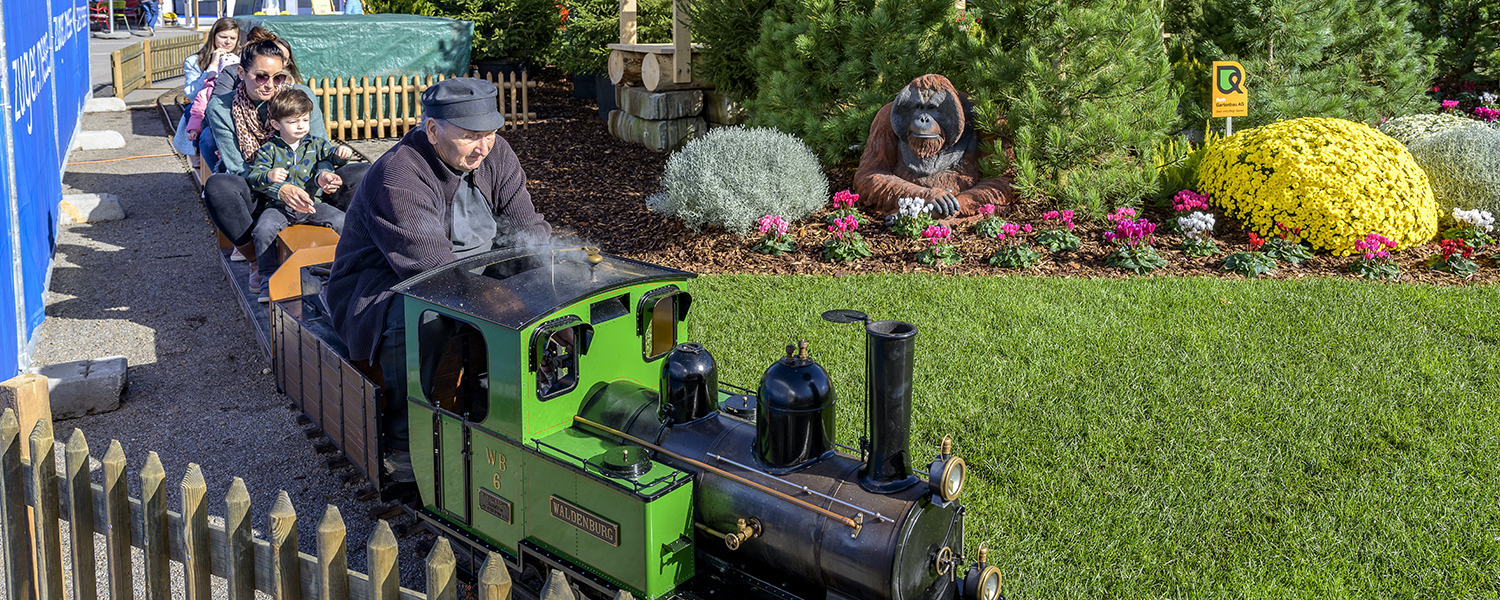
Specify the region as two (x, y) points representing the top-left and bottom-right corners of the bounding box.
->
(1197, 119), (1439, 257)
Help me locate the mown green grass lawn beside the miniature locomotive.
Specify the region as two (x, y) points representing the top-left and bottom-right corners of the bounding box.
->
(683, 276), (1500, 600)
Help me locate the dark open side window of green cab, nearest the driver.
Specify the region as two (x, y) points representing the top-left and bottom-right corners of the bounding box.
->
(417, 311), (489, 423)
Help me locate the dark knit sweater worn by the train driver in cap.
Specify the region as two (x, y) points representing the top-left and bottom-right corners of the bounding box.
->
(327, 128), (552, 360)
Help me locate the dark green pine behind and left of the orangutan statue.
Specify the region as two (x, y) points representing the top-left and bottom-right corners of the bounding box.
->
(746, 0), (956, 165)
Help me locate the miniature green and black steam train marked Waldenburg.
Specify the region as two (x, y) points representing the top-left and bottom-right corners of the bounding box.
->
(255, 238), (1001, 600)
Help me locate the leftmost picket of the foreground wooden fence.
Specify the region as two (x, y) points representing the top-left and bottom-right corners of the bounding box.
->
(0, 408), (36, 599)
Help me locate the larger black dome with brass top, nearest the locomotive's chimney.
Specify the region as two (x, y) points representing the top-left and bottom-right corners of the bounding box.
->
(755, 342), (839, 474)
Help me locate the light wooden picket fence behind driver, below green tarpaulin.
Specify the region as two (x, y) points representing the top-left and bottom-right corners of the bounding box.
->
(308, 72), (537, 141)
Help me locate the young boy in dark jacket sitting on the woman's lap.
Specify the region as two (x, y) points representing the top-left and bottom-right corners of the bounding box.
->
(246, 89), (354, 302)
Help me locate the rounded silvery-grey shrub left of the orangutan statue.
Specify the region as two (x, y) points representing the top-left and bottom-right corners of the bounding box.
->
(647, 128), (828, 236)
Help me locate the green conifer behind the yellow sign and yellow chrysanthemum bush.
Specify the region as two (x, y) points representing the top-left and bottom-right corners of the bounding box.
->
(1169, 0), (1433, 129)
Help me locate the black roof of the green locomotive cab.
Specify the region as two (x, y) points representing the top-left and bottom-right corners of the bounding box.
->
(392, 245), (696, 330)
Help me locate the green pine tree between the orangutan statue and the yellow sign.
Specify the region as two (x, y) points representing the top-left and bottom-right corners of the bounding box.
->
(960, 0), (1178, 212)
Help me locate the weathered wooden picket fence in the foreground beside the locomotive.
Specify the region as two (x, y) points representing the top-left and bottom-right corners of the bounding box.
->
(0, 408), (512, 600)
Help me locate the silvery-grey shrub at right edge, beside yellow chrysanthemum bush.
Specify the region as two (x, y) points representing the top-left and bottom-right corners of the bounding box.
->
(1407, 126), (1500, 218)
